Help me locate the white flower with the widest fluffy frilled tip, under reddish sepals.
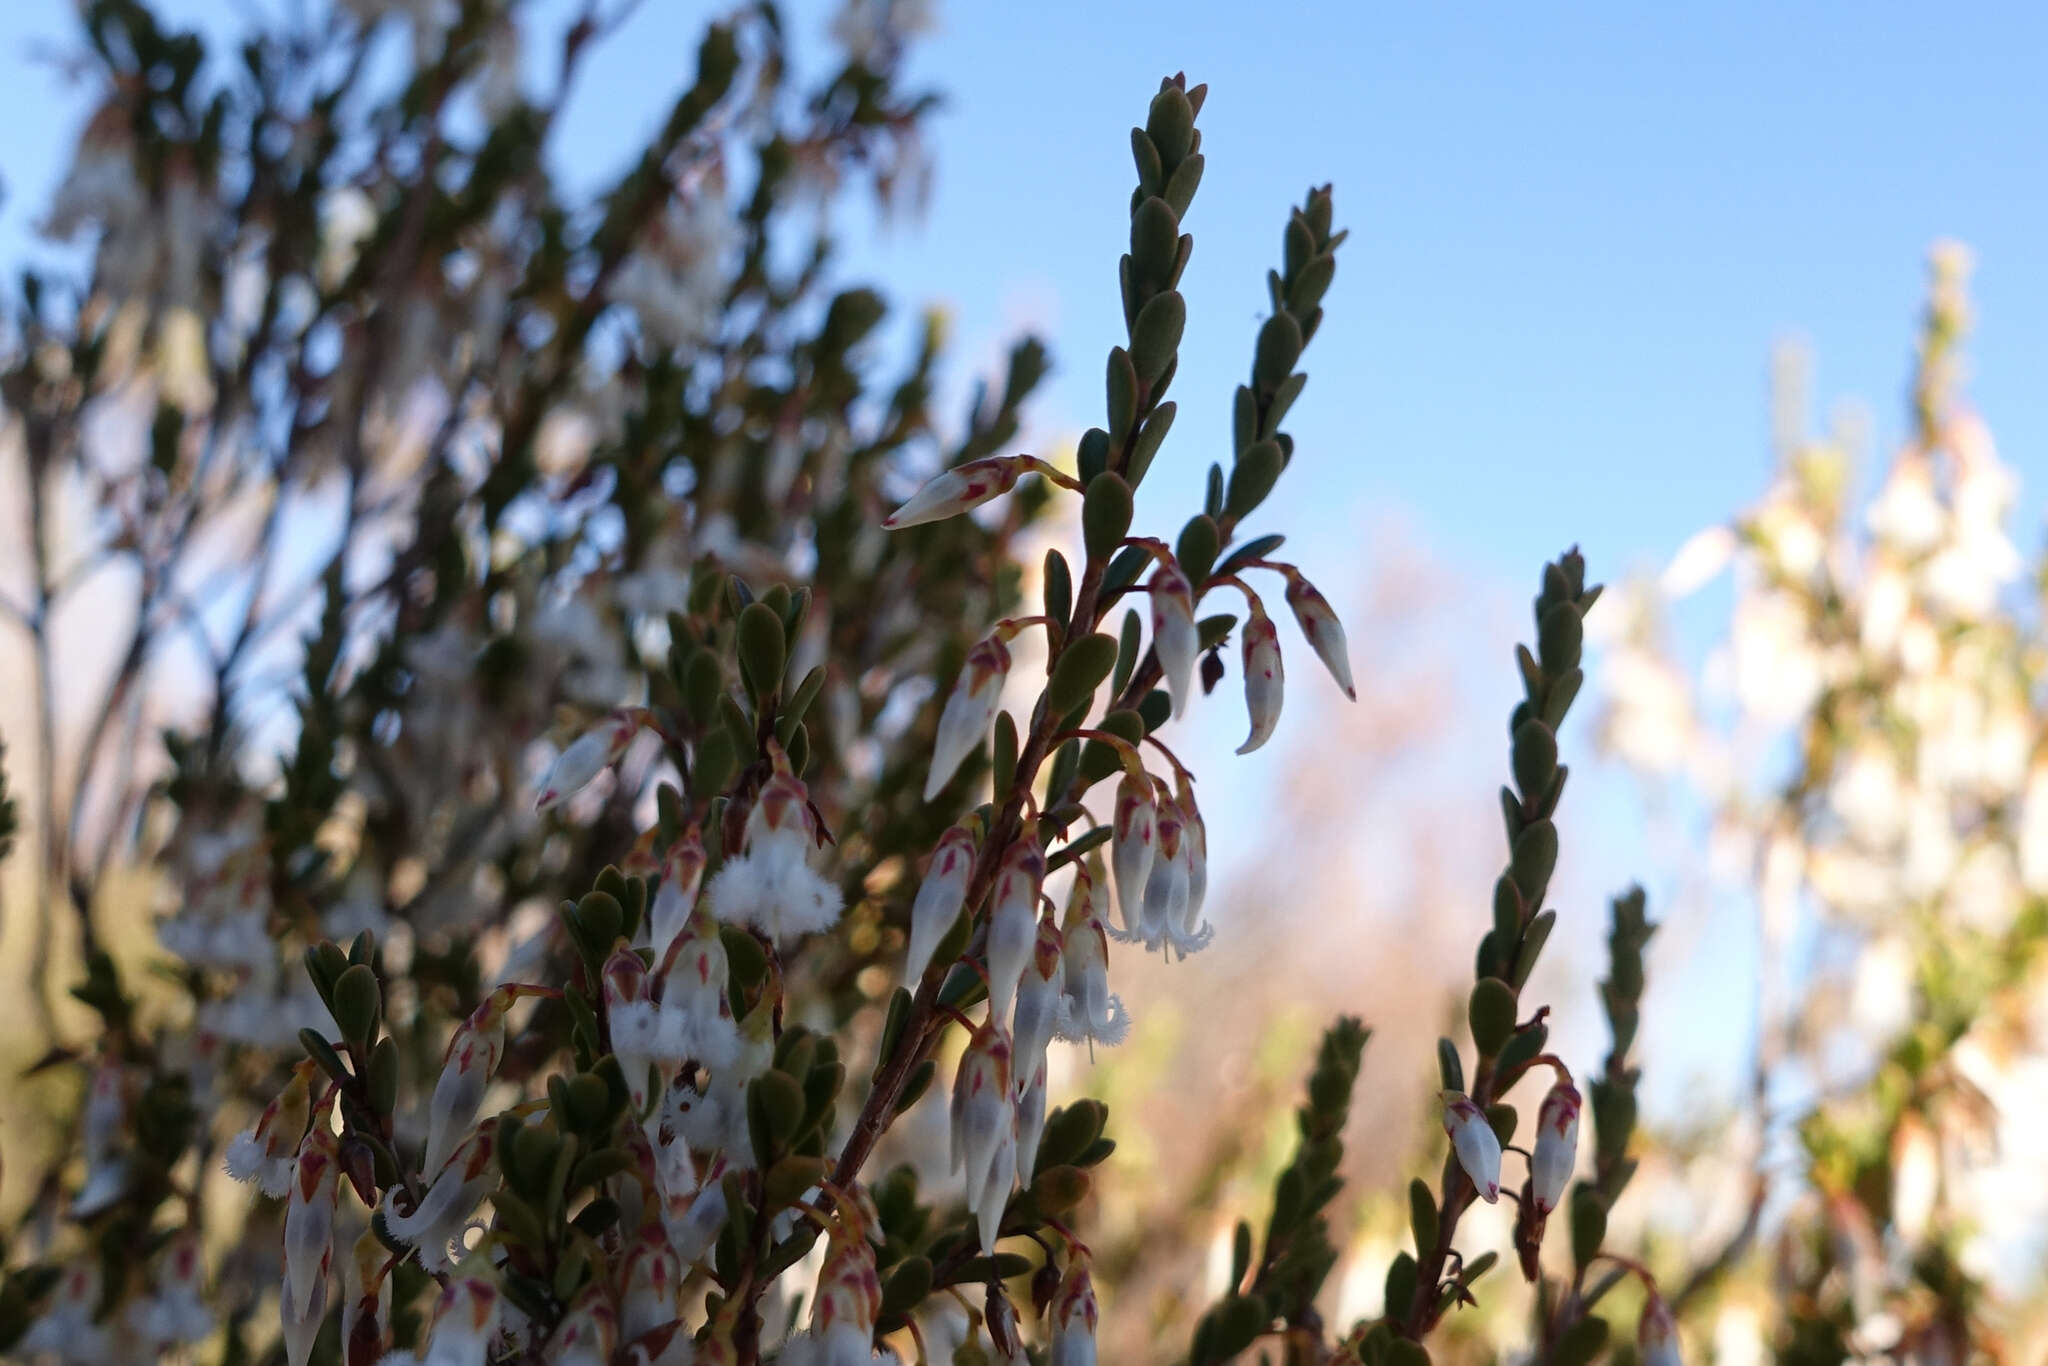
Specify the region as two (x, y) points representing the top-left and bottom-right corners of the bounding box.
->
(707, 741), (846, 944)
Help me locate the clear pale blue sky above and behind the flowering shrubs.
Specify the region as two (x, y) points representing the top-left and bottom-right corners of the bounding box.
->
(0, 0), (2048, 1114)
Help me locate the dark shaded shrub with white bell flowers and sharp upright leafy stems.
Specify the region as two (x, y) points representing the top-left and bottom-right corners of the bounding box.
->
(0, 0), (1675, 1366)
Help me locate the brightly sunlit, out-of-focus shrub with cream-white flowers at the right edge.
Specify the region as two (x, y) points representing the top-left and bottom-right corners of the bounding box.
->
(1602, 246), (2048, 1362)
